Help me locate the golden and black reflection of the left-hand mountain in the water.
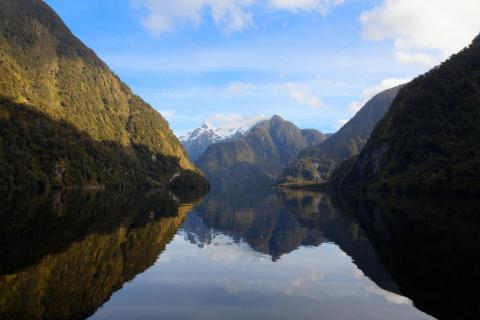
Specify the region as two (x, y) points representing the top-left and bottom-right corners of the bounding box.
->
(0, 193), (199, 319)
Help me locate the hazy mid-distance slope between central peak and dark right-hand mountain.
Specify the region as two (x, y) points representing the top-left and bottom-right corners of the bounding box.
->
(277, 86), (402, 185)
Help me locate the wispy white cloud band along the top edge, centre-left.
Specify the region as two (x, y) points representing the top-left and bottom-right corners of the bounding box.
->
(131, 0), (343, 36)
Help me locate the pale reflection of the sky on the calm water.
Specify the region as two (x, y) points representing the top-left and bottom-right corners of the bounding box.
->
(92, 234), (431, 320)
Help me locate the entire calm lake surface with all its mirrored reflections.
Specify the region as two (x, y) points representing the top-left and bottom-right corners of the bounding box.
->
(0, 189), (480, 320)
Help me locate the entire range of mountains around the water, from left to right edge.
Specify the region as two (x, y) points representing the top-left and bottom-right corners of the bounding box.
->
(0, 0), (480, 194)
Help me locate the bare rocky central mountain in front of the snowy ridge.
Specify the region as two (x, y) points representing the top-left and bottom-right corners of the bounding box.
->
(196, 116), (326, 186)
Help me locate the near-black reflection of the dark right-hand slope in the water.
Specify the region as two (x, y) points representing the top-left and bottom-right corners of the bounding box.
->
(338, 192), (480, 319)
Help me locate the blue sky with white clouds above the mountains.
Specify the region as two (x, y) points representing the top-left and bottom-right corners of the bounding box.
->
(45, 0), (480, 135)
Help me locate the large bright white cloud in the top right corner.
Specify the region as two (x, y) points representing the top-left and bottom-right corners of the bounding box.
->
(360, 0), (480, 66)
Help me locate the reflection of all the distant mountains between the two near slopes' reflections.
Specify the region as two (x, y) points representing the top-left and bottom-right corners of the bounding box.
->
(183, 189), (398, 292)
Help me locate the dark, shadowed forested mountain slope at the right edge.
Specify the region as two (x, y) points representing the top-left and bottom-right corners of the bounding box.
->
(335, 36), (480, 193)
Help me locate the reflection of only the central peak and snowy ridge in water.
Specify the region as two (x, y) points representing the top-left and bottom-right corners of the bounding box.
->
(184, 189), (323, 260)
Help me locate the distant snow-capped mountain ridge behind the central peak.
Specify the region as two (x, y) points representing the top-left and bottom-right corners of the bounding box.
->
(180, 116), (266, 162)
